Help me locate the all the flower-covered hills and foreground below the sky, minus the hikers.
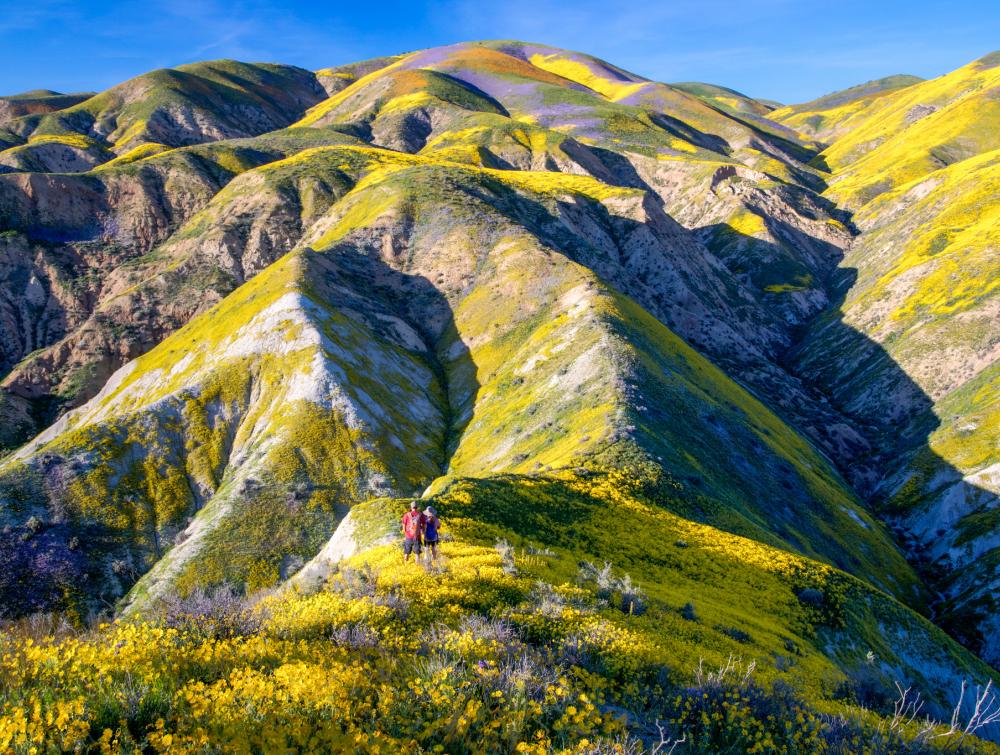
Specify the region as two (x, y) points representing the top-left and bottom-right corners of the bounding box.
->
(0, 41), (1000, 752)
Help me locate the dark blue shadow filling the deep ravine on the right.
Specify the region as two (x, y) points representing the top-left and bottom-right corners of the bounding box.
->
(699, 218), (1000, 666)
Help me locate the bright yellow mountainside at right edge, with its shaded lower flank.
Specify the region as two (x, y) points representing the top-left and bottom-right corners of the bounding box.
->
(776, 54), (1000, 663)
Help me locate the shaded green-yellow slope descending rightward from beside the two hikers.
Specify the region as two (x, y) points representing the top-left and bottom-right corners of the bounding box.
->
(424, 468), (988, 716)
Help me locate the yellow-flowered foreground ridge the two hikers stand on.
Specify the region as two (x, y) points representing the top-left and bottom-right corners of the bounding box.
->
(0, 471), (995, 753)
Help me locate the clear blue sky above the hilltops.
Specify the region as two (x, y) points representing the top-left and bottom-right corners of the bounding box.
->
(0, 0), (1000, 102)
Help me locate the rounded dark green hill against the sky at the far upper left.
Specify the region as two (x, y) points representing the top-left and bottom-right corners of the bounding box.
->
(0, 60), (324, 173)
